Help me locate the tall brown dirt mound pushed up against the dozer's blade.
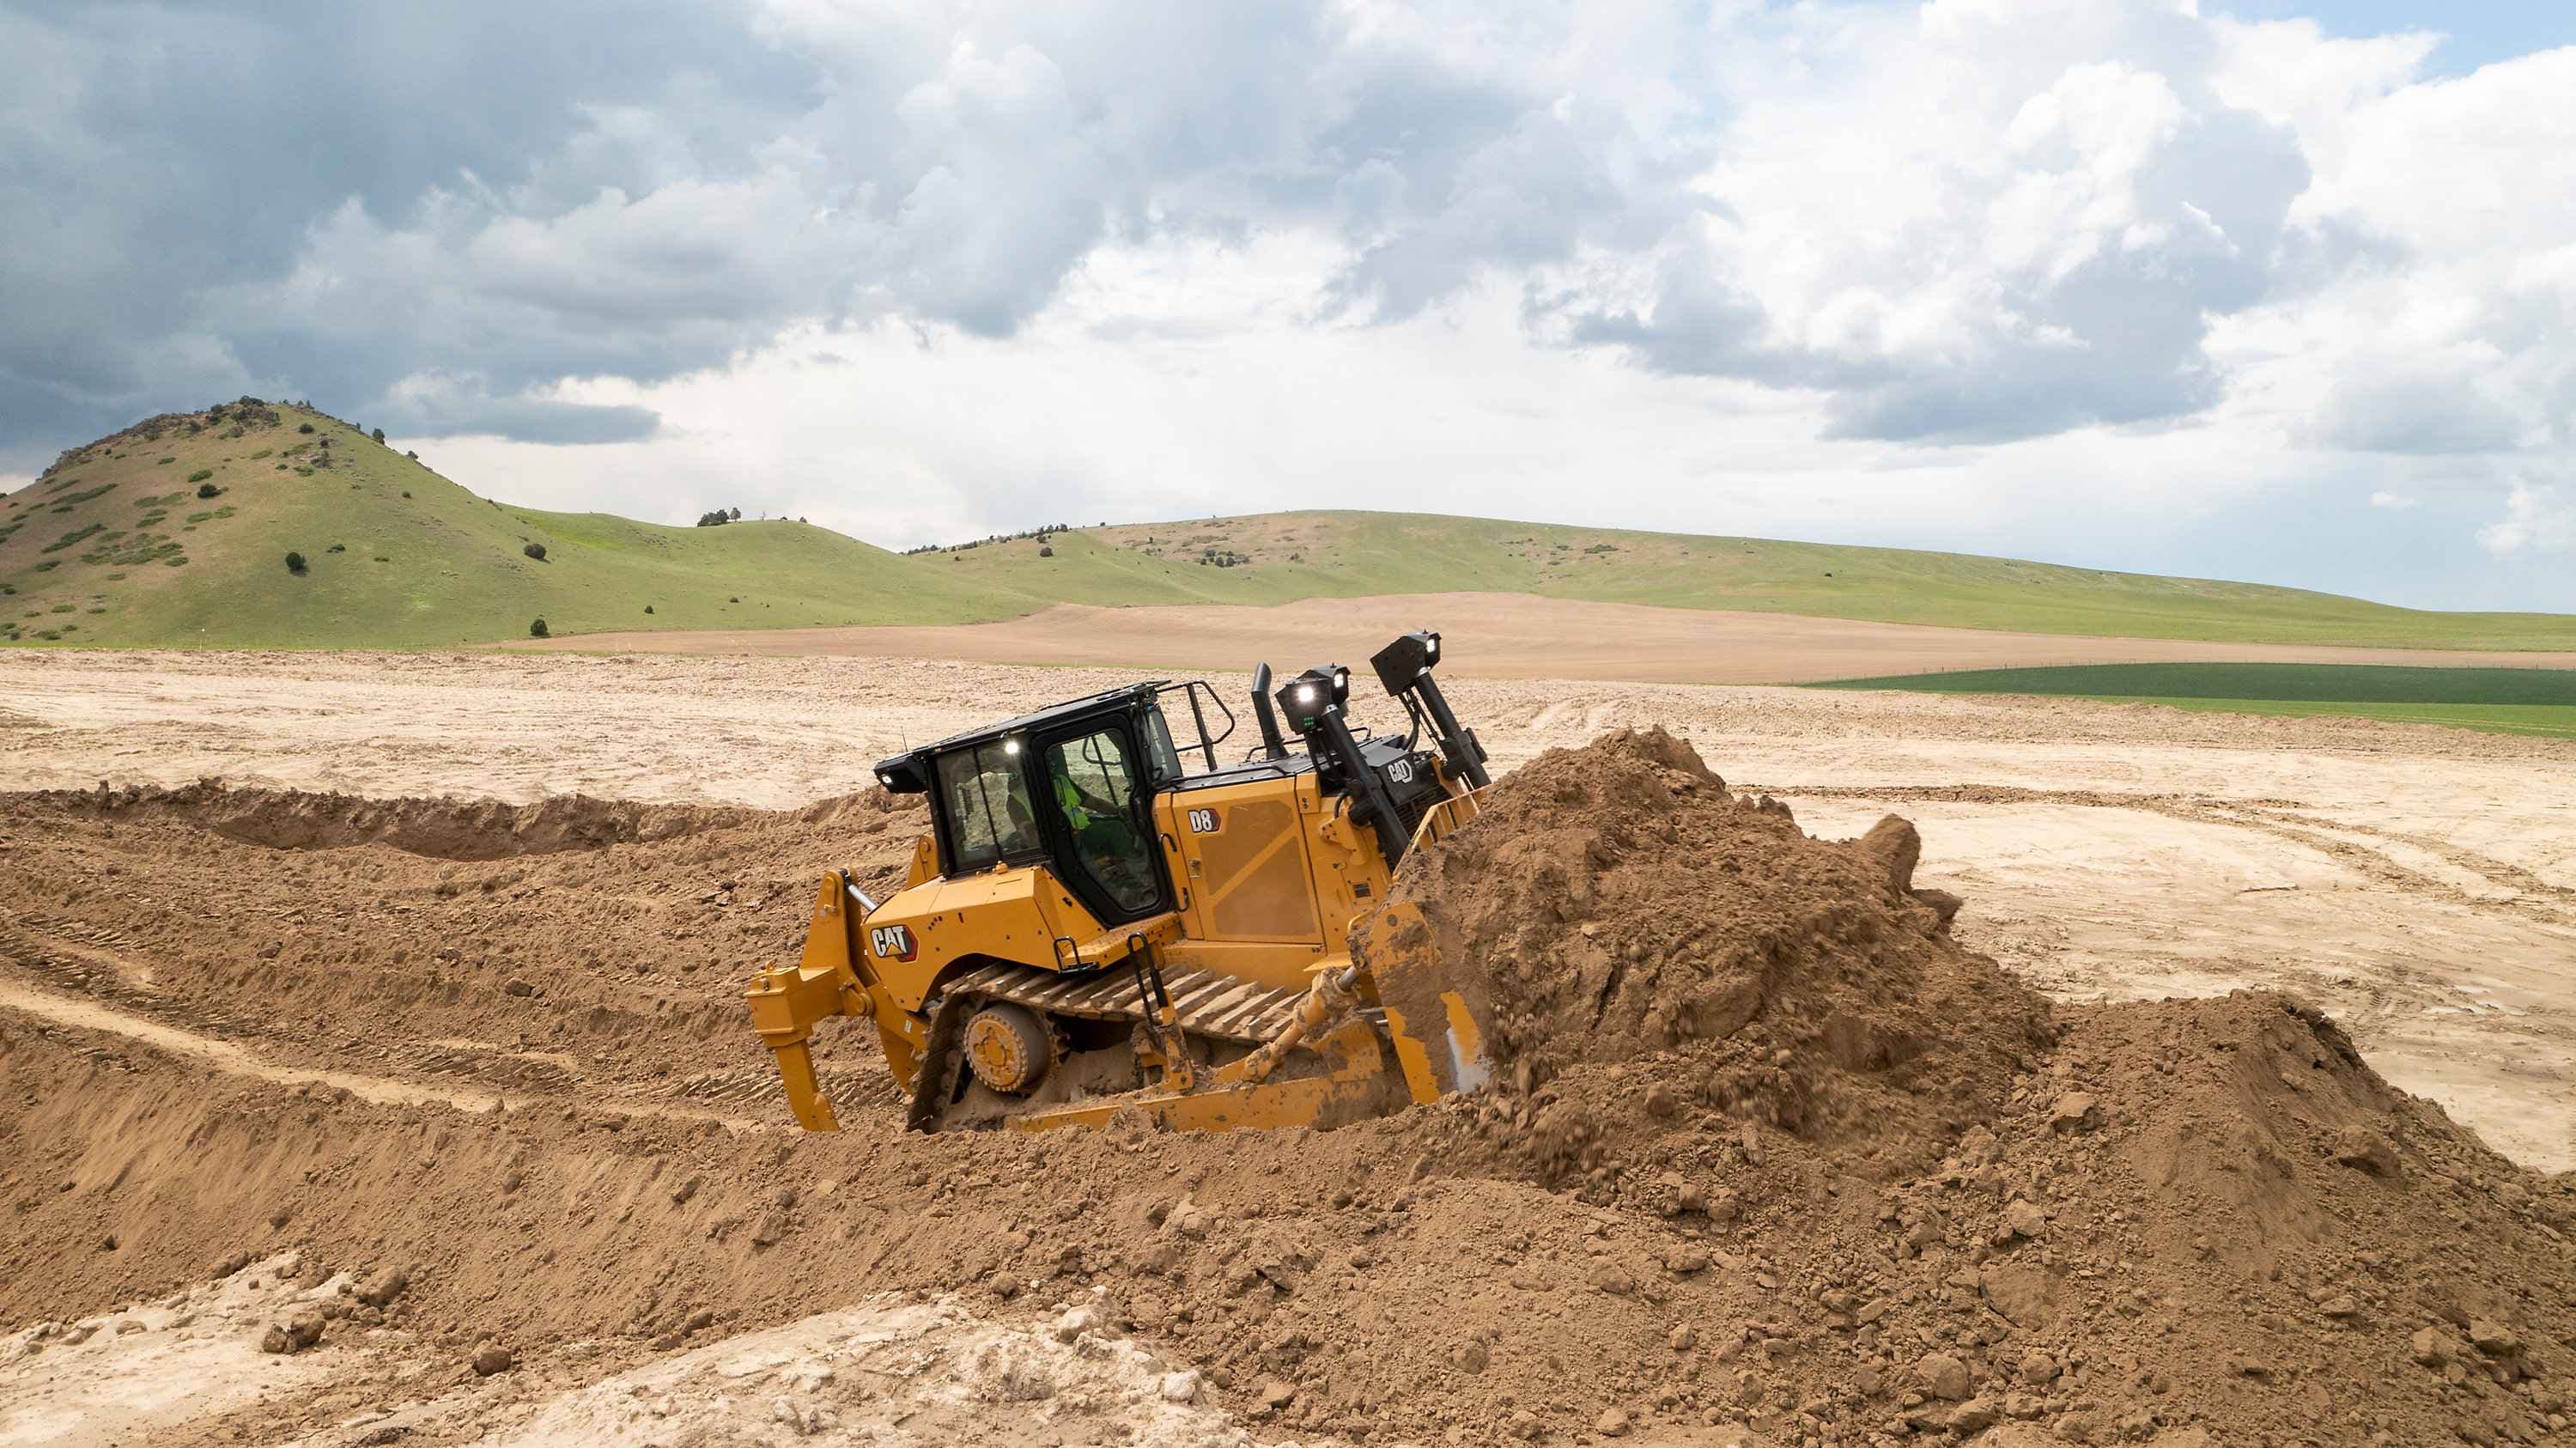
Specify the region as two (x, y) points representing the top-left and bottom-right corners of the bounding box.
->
(1358, 729), (2053, 1175)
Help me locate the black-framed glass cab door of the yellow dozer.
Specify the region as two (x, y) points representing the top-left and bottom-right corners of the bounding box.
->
(1033, 719), (1172, 925)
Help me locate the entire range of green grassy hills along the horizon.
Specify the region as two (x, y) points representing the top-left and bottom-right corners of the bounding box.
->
(15, 399), (2576, 649)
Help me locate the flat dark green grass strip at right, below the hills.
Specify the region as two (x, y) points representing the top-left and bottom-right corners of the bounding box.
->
(1811, 665), (2576, 739)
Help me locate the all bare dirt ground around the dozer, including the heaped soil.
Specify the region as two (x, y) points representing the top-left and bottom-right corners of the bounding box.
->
(0, 654), (2576, 1448)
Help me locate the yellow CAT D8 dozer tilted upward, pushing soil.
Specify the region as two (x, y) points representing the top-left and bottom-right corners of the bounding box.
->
(750, 634), (1492, 1131)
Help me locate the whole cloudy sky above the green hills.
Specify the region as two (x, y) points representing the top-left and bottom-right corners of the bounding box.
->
(0, 0), (2576, 608)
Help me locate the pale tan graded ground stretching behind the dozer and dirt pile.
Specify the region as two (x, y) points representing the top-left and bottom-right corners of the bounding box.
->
(0, 642), (2576, 1170)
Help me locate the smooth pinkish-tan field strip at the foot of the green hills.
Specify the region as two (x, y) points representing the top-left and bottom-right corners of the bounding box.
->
(510, 593), (2576, 683)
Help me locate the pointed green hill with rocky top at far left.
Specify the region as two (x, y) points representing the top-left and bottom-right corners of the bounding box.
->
(0, 397), (1030, 647)
